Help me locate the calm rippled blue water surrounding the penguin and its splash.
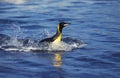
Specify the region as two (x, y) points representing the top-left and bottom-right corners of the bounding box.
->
(0, 0), (120, 78)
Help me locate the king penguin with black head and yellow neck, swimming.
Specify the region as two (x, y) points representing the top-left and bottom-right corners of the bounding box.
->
(40, 22), (70, 44)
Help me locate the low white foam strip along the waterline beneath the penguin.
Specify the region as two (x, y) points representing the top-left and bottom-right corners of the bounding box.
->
(1, 42), (86, 52)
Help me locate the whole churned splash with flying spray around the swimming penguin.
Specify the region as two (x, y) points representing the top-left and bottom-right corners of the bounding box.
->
(1, 28), (85, 52)
